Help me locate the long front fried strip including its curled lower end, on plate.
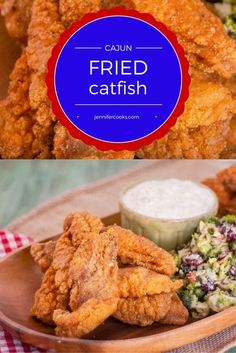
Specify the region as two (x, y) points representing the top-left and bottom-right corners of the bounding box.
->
(53, 227), (118, 337)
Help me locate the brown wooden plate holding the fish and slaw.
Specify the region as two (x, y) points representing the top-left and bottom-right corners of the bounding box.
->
(0, 214), (236, 353)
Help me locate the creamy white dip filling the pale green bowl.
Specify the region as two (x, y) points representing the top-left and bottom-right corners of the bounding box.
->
(122, 179), (216, 220)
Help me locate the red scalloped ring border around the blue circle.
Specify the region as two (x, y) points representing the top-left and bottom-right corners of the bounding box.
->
(46, 7), (191, 152)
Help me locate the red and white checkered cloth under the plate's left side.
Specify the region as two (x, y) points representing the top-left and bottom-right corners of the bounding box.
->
(0, 231), (44, 353)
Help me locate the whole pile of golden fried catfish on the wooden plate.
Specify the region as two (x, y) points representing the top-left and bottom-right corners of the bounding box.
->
(31, 212), (188, 337)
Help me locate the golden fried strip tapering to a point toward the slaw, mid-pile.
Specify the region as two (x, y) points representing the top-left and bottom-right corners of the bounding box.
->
(118, 267), (183, 298)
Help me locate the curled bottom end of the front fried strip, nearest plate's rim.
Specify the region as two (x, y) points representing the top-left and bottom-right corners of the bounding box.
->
(53, 298), (118, 337)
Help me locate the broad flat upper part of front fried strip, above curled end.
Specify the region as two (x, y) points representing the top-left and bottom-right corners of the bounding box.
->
(68, 227), (118, 311)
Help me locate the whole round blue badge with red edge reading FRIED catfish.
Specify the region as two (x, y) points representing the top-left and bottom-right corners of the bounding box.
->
(47, 9), (189, 150)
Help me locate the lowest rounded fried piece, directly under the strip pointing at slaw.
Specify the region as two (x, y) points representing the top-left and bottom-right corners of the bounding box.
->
(113, 293), (173, 326)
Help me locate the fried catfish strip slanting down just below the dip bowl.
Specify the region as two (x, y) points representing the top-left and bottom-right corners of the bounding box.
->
(104, 226), (176, 275)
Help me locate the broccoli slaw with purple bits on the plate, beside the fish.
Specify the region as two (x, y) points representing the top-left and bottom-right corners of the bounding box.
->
(174, 216), (236, 319)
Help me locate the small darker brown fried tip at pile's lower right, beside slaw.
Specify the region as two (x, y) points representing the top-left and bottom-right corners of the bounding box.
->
(160, 293), (189, 326)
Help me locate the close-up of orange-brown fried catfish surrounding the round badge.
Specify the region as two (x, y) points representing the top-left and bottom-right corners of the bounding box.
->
(0, 0), (236, 159)
